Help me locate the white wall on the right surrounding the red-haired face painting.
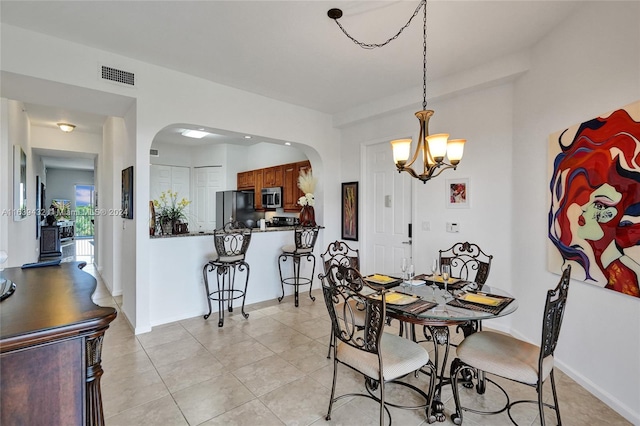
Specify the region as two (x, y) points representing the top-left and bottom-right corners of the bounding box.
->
(512, 2), (640, 424)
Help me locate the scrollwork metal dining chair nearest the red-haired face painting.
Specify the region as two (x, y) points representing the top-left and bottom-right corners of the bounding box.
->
(451, 265), (571, 426)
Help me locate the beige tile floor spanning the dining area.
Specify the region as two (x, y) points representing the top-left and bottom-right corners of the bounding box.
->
(85, 266), (630, 426)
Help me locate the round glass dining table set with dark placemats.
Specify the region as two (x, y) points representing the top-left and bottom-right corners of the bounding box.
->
(365, 276), (518, 422)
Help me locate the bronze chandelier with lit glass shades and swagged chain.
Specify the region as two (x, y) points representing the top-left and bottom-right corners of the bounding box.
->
(327, 0), (466, 183)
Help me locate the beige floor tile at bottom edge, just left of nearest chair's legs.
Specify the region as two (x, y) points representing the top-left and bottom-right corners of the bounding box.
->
(260, 376), (330, 425)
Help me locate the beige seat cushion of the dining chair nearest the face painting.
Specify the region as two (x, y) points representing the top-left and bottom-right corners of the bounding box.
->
(457, 331), (553, 385)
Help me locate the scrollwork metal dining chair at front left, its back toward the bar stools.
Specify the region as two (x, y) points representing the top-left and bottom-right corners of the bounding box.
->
(321, 264), (435, 425)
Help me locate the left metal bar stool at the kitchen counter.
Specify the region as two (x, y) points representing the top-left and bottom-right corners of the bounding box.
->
(202, 222), (251, 327)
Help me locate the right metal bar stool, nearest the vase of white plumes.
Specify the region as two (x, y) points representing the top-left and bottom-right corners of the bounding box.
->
(278, 226), (320, 307)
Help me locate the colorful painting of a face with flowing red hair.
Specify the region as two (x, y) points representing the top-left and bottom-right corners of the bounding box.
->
(548, 102), (640, 297)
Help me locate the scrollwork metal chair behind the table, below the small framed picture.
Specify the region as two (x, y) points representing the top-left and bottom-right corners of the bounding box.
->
(440, 242), (493, 287)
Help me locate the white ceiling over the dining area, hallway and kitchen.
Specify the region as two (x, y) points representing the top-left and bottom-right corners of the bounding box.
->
(0, 0), (584, 169)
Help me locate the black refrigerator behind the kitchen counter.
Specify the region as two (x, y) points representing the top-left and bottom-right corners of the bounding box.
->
(216, 191), (264, 228)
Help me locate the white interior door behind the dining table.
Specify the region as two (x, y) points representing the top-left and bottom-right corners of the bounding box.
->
(362, 142), (413, 274)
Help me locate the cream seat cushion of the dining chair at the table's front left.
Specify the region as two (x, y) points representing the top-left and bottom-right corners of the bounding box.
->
(336, 333), (429, 381)
